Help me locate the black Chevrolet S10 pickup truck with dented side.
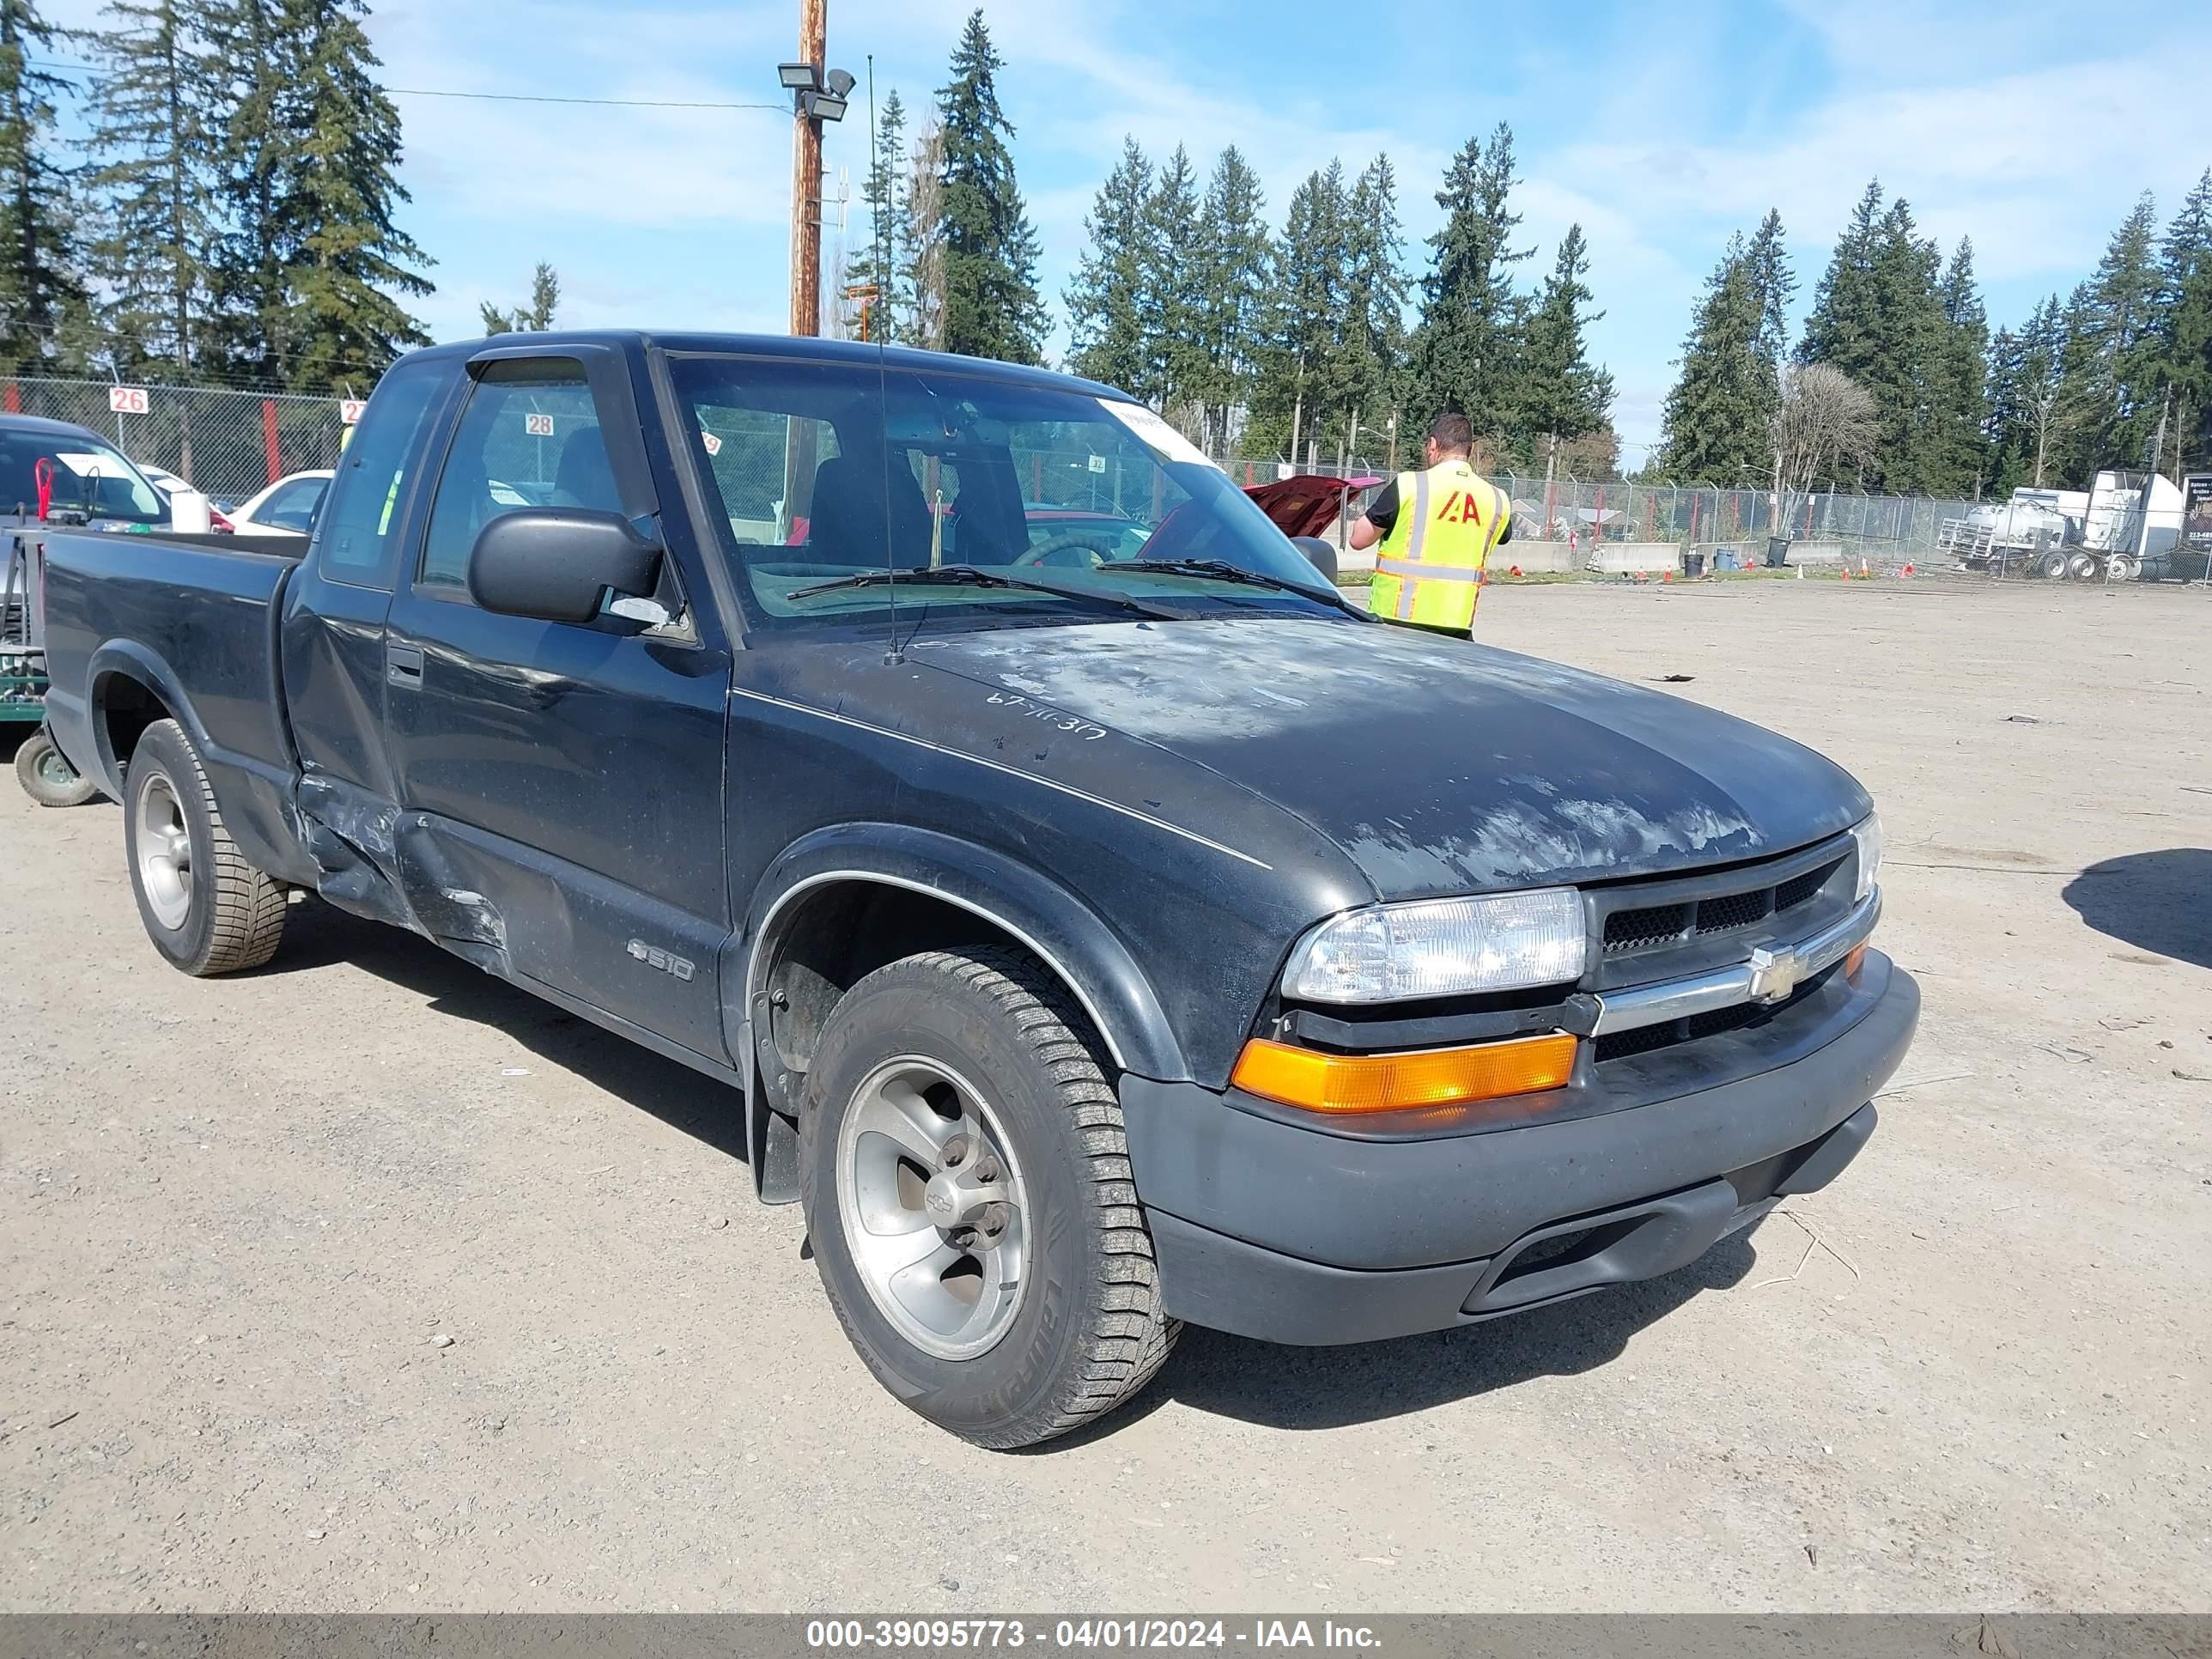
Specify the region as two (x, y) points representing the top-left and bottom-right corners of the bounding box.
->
(45, 334), (1917, 1447)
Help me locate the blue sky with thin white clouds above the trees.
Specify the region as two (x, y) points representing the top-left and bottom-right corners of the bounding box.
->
(49, 0), (2212, 465)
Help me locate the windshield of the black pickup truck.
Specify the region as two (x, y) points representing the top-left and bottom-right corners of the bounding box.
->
(671, 356), (1343, 629)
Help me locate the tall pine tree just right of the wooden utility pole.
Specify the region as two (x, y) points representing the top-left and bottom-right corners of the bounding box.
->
(938, 7), (1044, 362)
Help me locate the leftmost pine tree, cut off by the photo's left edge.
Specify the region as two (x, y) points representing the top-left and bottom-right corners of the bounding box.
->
(0, 0), (86, 374)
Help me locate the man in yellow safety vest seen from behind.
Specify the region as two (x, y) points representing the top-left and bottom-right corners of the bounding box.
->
(1352, 414), (1513, 639)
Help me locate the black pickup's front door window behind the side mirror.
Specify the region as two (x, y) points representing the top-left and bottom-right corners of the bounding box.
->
(420, 358), (622, 588)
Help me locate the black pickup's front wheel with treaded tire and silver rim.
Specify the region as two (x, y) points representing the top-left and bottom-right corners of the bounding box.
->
(799, 947), (1182, 1451)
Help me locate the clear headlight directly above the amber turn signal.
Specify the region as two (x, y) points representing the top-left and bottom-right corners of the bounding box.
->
(1283, 887), (1589, 1002)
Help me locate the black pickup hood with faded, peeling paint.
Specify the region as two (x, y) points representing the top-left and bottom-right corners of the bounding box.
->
(911, 619), (1871, 898)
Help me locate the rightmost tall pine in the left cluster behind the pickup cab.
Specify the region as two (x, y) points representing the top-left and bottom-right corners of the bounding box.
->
(276, 0), (431, 392)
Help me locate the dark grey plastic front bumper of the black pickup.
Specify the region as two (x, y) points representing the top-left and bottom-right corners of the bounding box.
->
(1121, 951), (1920, 1345)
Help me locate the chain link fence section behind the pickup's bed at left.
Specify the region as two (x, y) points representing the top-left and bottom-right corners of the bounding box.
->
(0, 376), (349, 507)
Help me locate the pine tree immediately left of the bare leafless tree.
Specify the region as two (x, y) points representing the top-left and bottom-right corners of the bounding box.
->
(1663, 232), (1778, 484)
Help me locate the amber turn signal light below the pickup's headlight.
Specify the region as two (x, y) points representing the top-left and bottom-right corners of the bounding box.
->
(1230, 1030), (1575, 1113)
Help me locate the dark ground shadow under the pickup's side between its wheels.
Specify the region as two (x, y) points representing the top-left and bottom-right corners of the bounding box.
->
(261, 902), (745, 1164)
